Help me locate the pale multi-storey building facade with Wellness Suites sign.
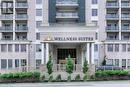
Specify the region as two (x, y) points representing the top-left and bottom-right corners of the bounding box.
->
(0, 0), (130, 72)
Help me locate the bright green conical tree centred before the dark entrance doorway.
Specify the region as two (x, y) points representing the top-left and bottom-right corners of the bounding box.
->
(66, 55), (74, 80)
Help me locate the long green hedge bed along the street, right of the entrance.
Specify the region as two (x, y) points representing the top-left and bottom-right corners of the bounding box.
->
(95, 70), (130, 80)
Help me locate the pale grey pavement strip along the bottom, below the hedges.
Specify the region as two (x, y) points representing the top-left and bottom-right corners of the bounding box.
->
(0, 81), (130, 87)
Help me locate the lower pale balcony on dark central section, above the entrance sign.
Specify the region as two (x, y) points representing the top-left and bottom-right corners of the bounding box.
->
(56, 13), (78, 19)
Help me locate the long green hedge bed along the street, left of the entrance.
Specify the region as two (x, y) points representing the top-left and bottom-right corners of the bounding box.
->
(0, 72), (40, 83)
